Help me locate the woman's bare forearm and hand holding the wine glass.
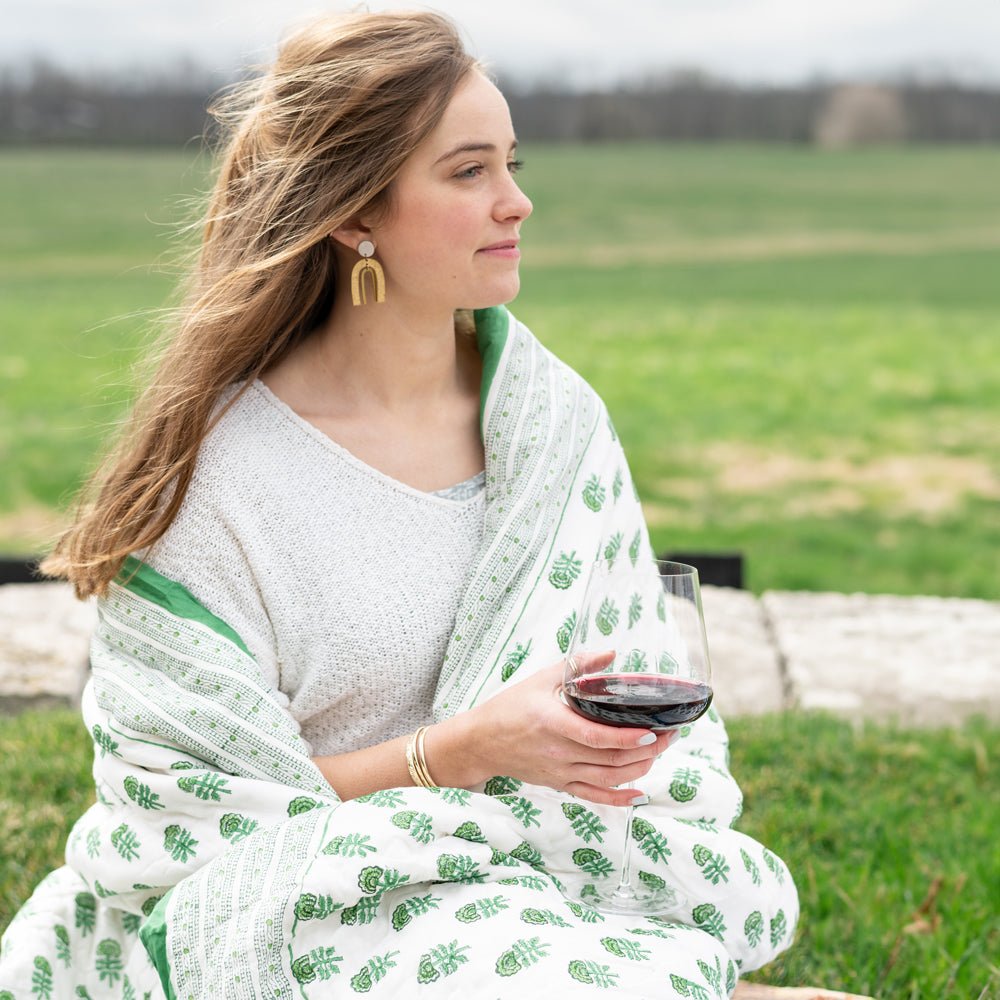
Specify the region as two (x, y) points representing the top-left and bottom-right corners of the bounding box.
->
(313, 656), (671, 805)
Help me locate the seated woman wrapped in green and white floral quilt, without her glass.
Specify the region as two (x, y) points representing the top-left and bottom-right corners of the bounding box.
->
(0, 13), (797, 998)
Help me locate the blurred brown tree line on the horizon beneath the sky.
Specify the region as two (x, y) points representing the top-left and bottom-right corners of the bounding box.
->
(0, 63), (1000, 146)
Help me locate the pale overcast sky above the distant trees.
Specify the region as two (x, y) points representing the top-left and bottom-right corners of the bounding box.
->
(0, 0), (1000, 85)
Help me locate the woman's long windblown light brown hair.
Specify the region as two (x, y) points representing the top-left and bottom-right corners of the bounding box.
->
(41, 12), (476, 597)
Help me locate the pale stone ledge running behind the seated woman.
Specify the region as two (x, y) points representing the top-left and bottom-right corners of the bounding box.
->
(0, 583), (1000, 726)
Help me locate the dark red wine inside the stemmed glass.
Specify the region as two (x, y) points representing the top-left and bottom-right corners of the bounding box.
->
(563, 673), (712, 730)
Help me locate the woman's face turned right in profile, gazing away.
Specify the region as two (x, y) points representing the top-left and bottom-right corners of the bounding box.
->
(372, 71), (531, 311)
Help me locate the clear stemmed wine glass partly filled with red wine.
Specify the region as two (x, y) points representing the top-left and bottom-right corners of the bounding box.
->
(563, 557), (712, 916)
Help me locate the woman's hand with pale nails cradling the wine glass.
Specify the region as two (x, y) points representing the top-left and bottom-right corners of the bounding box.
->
(425, 653), (673, 806)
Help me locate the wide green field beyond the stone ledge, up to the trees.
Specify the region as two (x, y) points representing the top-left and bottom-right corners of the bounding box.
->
(0, 145), (1000, 598)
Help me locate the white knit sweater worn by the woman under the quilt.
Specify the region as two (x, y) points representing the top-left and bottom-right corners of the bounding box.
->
(146, 382), (485, 754)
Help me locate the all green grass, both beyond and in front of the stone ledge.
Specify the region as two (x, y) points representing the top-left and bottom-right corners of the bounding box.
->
(0, 145), (1000, 1000)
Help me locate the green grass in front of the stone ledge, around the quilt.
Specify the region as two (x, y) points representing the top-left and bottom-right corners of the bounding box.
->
(0, 711), (1000, 1000)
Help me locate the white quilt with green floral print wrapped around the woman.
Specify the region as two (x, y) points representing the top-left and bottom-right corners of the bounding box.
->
(0, 309), (798, 1000)
